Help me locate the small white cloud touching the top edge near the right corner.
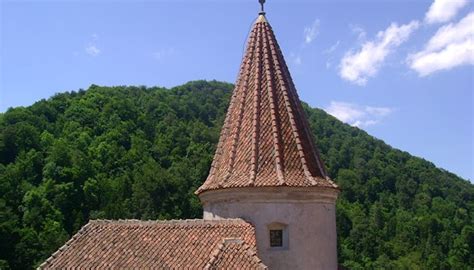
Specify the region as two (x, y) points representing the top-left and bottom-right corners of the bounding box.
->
(425, 0), (468, 24)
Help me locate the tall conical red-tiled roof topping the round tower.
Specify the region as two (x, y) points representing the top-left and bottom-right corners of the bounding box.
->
(196, 14), (337, 194)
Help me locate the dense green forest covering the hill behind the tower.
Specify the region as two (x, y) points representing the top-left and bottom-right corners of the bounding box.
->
(0, 81), (474, 269)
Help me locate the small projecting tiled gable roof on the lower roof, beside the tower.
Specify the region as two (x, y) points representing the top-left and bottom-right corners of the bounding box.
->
(204, 238), (268, 270)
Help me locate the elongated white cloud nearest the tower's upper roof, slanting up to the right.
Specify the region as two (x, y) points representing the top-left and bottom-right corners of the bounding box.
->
(339, 21), (419, 85)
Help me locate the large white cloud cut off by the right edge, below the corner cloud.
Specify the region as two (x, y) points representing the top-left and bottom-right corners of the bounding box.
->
(407, 12), (474, 77)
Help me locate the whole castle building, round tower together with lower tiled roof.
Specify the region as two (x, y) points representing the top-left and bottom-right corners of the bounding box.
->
(39, 0), (339, 269)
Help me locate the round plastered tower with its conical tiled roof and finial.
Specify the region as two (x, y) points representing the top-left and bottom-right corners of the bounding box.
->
(196, 1), (339, 269)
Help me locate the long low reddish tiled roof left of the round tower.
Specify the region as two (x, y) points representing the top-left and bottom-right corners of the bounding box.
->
(39, 219), (264, 269)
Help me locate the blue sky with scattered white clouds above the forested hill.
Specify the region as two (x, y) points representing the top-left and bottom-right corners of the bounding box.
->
(0, 0), (474, 181)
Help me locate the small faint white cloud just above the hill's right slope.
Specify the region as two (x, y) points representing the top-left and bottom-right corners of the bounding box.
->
(324, 101), (393, 128)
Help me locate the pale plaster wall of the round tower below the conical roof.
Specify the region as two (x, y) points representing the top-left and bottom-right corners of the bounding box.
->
(203, 188), (337, 270)
